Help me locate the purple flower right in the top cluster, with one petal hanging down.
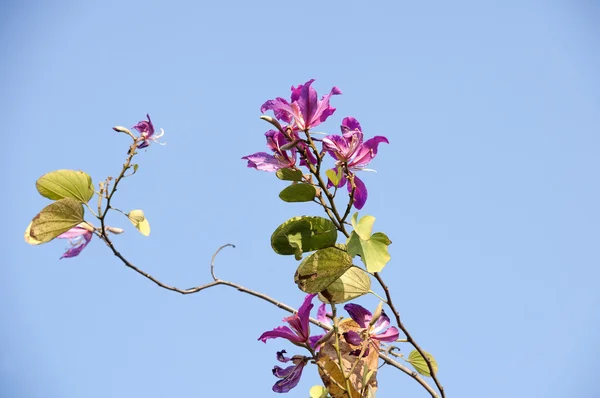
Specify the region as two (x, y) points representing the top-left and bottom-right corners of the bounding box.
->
(323, 117), (389, 210)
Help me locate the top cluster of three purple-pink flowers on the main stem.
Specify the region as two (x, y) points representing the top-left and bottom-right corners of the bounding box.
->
(242, 79), (389, 209)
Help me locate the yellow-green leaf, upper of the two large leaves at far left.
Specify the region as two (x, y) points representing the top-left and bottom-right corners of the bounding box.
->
(35, 170), (94, 203)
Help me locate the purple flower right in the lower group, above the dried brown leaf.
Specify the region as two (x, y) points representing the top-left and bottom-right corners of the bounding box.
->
(344, 304), (400, 355)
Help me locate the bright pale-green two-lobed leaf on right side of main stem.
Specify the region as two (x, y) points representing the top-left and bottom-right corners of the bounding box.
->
(346, 231), (392, 273)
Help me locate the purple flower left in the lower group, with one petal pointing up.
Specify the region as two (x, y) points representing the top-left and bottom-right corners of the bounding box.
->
(258, 294), (323, 347)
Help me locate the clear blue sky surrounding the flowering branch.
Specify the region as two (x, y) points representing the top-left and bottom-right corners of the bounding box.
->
(0, 0), (600, 398)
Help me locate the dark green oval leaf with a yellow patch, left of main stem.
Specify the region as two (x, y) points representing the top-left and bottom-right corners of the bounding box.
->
(271, 216), (337, 260)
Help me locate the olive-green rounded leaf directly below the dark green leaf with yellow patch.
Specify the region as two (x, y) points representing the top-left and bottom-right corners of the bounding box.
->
(294, 246), (352, 293)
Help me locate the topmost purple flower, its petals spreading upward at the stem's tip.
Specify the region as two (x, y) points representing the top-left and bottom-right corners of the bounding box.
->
(260, 79), (342, 130)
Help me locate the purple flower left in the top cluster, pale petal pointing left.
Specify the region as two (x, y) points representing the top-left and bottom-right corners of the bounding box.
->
(242, 130), (296, 172)
